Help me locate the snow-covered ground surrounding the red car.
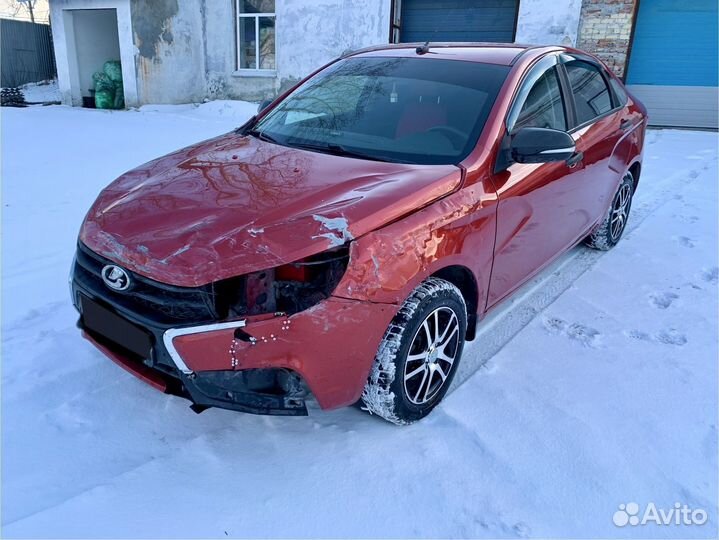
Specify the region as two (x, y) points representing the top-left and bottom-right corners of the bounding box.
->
(1, 102), (719, 538)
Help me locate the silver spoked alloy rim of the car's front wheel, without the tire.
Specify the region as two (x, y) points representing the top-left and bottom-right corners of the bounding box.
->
(404, 307), (460, 405)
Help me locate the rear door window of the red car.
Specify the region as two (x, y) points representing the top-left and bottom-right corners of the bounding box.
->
(564, 60), (612, 124)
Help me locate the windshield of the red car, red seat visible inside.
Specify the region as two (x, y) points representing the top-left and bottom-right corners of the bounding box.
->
(252, 57), (509, 164)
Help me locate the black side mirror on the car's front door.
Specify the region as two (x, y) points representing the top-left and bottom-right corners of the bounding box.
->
(510, 127), (576, 163)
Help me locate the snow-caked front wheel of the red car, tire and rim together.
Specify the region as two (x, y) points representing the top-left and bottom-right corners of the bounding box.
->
(361, 278), (467, 425)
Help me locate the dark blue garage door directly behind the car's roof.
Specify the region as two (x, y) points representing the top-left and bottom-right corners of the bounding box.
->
(400, 0), (519, 43)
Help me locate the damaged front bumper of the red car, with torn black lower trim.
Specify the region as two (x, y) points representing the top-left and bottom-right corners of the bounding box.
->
(71, 247), (397, 415)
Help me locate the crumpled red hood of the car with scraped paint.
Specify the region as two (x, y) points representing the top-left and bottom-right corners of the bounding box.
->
(80, 134), (461, 287)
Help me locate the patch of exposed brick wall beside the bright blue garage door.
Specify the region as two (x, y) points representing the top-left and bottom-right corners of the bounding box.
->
(577, 0), (636, 77)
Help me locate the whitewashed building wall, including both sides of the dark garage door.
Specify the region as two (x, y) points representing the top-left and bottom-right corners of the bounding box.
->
(50, 0), (582, 106)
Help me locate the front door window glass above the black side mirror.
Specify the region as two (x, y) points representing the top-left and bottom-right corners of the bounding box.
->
(513, 68), (567, 131)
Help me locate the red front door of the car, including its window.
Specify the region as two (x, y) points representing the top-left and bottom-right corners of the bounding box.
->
(487, 56), (588, 307)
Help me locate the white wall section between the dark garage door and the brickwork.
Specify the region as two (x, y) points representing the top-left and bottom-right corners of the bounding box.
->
(514, 0), (582, 46)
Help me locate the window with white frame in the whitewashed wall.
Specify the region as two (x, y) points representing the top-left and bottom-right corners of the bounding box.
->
(235, 0), (275, 71)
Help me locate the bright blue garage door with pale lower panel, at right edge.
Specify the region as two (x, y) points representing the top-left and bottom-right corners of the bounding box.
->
(627, 0), (719, 127)
